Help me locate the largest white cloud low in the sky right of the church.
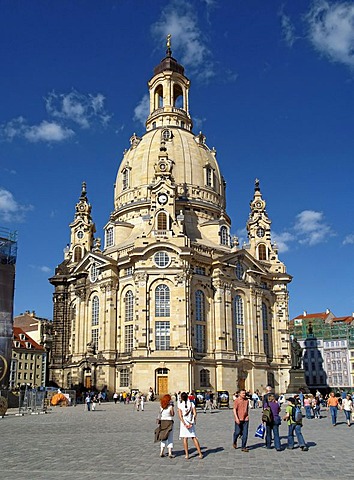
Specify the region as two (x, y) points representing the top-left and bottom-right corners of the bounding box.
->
(294, 210), (334, 245)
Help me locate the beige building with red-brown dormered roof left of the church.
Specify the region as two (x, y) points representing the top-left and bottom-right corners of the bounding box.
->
(9, 327), (47, 389)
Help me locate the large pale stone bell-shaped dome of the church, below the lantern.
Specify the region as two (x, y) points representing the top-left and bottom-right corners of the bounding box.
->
(114, 127), (225, 210)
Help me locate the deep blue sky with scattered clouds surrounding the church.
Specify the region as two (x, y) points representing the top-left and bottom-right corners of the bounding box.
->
(0, 0), (354, 318)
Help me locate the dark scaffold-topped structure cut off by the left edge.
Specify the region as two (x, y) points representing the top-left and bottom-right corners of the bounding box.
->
(0, 228), (17, 389)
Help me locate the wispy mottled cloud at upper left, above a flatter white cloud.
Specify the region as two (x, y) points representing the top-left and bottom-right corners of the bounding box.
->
(45, 90), (111, 128)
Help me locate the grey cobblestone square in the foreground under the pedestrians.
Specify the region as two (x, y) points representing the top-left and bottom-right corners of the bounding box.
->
(0, 402), (354, 480)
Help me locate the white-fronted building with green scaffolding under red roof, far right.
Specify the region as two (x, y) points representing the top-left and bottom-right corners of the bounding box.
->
(290, 310), (354, 390)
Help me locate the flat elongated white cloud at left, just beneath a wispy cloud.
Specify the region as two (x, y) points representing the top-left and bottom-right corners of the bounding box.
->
(0, 117), (75, 142)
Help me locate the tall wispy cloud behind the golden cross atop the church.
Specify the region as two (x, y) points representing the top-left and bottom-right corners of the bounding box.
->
(152, 0), (215, 80)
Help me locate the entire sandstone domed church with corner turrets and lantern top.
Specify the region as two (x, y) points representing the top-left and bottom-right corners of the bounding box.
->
(50, 40), (291, 394)
